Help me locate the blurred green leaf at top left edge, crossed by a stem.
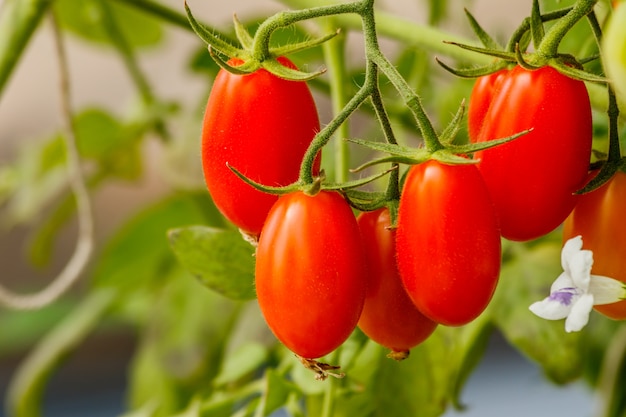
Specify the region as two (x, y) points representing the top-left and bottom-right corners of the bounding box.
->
(54, 0), (163, 47)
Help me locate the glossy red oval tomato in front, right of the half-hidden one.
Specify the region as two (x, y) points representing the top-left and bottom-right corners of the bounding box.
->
(396, 161), (501, 326)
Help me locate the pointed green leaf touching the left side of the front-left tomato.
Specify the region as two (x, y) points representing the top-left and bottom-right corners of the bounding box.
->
(168, 226), (256, 300)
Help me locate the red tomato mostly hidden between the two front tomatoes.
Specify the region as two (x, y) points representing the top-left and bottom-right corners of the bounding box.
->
(357, 208), (437, 359)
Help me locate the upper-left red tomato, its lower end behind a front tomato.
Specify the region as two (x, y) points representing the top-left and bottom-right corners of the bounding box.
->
(202, 58), (320, 235)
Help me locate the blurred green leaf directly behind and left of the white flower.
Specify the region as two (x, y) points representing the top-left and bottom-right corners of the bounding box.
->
(489, 241), (584, 384)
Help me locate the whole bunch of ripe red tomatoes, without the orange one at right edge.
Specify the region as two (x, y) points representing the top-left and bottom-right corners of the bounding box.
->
(202, 59), (596, 360)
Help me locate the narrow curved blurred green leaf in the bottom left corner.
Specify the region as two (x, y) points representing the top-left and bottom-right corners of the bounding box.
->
(7, 290), (116, 417)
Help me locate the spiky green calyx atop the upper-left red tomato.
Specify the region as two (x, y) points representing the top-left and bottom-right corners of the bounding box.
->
(185, 1), (340, 81)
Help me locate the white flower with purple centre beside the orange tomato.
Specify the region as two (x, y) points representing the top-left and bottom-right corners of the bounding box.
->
(529, 236), (626, 333)
